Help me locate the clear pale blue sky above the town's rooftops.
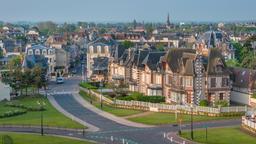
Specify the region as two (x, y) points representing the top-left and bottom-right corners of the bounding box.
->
(0, 0), (256, 22)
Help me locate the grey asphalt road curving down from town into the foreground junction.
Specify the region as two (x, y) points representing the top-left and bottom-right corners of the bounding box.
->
(0, 76), (241, 144)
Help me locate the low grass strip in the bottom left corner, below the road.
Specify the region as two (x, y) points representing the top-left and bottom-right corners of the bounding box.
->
(0, 132), (92, 144)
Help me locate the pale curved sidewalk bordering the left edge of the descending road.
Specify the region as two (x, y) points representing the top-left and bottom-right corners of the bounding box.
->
(47, 95), (99, 132)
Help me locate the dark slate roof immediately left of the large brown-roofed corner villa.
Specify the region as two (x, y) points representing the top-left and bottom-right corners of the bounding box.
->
(142, 52), (165, 71)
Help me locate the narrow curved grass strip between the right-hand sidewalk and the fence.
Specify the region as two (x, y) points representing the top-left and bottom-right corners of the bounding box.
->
(80, 91), (143, 117)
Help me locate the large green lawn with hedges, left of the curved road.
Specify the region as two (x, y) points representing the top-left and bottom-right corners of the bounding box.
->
(0, 97), (84, 128)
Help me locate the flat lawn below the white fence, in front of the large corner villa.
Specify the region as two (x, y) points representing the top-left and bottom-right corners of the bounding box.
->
(128, 112), (239, 125)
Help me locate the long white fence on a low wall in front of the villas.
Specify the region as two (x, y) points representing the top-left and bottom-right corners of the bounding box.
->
(80, 88), (253, 116)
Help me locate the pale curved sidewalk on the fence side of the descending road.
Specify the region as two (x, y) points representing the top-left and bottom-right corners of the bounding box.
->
(73, 94), (154, 128)
